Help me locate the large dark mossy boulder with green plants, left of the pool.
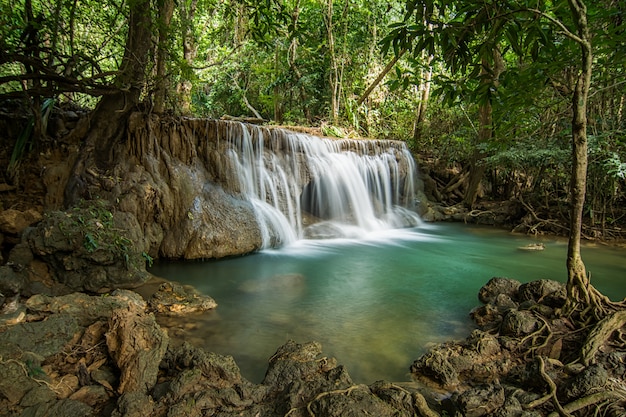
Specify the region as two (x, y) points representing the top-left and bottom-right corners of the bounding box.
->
(24, 206), (149, 292)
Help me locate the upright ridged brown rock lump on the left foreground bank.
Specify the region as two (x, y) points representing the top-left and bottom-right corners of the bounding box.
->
(106, 298), (169, 394)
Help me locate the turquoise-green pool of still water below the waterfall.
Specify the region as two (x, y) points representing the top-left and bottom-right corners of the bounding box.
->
(151, 224), (626, 383)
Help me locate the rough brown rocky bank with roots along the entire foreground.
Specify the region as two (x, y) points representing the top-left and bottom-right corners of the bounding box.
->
(0, 264), (626, 417)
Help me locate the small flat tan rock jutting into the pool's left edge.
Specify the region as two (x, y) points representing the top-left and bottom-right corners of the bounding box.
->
(148, 282), (217, 316)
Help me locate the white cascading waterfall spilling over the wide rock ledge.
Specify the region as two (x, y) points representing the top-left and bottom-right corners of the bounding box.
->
(219, 123), (419, 247)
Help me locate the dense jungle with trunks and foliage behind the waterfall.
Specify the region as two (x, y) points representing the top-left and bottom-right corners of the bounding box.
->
(0, 0), (626, 240)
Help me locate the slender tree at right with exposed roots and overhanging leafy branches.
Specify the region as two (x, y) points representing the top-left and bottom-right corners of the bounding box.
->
(386, 0), (617, 320)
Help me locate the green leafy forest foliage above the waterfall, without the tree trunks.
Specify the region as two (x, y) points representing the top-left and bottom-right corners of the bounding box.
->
(0, 0), (626, 224)
